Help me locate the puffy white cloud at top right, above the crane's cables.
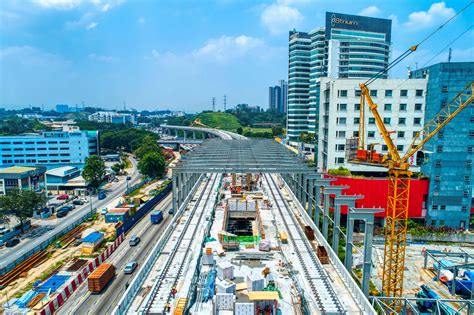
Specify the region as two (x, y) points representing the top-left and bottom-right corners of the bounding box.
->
(405, 2), (456, 29)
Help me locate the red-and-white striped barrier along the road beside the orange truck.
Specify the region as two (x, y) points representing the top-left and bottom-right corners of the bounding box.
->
(40, 234), (124, 315)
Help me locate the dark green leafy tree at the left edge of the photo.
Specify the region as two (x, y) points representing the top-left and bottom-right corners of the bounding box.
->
(0, 189), (46, 233)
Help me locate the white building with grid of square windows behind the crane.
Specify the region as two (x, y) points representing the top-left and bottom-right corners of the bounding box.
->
(316, 78), (427, 172)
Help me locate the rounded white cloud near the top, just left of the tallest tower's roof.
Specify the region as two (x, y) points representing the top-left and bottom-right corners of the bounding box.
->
(260, 3), (304, 35)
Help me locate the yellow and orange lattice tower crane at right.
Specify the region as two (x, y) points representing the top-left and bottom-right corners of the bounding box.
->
(350, 82), (474, 311)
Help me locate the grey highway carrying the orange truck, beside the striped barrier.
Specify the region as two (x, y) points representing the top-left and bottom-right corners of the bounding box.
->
(58, 194), (172, 315)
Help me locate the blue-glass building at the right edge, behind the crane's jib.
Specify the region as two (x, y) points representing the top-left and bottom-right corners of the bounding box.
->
(410, 62), (474, 228)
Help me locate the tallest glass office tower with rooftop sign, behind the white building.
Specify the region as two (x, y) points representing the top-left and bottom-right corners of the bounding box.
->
(287, 12), (392, 140)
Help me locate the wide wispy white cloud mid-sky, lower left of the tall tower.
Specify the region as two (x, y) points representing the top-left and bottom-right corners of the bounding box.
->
(193, 35), (265, 62)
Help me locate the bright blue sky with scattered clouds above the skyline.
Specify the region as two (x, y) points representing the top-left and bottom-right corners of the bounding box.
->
(0, 0), (474, 112)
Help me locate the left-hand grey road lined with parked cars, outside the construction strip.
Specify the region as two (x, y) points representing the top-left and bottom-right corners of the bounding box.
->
(0, 158), (140, 270)
